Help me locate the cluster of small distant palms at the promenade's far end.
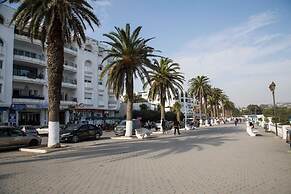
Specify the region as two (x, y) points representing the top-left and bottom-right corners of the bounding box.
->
(188, 75), (235, 123)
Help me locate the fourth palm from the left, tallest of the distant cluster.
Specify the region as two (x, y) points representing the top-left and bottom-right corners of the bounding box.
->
(189, 75), (209, 122)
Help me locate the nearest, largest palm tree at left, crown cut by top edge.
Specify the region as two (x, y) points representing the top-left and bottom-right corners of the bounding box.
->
(9, 0), (99, 147)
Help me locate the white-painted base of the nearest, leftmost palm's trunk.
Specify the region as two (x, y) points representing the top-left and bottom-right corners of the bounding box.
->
(47, 121), (60, 147)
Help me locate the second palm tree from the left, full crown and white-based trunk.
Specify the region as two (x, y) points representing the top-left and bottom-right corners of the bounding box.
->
(101, 24), (156, 136)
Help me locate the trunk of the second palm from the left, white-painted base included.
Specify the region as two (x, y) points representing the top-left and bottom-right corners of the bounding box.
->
(125, 74), (133, 137)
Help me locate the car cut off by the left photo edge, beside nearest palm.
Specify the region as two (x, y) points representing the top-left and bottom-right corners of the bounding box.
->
(0, 126), (41, 150)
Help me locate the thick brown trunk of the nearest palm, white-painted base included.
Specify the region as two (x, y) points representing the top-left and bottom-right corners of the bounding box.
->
(47, 16), (64, 147)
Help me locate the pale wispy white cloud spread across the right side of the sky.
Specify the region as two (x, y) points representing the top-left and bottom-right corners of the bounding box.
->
(173, 11), (291, 106)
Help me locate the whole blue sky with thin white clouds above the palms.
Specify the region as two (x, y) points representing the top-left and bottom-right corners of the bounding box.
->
(88, 0), (291, 107)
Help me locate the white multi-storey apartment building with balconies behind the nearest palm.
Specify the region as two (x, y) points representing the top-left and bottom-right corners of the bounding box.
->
(0, 5), (119, 125)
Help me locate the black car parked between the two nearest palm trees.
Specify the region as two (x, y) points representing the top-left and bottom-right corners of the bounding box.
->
(60, 124), (102, 143)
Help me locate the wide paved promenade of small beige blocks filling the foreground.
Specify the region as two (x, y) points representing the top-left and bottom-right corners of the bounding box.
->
(0, 125), (291, 194)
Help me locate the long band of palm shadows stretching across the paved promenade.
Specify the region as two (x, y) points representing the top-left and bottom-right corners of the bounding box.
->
(0, 126), (244, 165)
